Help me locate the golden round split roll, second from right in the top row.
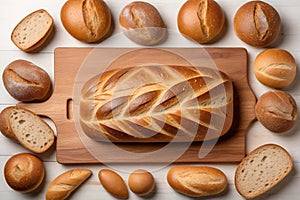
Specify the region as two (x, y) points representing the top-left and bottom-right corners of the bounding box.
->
(177, 0), (225, 44)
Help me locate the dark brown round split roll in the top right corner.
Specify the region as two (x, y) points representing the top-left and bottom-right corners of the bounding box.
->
(234, 1), (281, 47)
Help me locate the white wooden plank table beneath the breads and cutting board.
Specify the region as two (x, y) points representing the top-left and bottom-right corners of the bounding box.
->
(0, 0), (300, 200)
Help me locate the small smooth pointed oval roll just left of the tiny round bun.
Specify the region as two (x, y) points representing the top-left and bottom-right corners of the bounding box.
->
(98, 169), (129, 199)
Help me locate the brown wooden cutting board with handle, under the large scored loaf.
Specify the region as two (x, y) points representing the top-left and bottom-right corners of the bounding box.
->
(20, 48), (256, 164)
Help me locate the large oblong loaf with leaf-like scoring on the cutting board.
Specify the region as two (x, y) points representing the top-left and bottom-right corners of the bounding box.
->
(80, 65), (233, 142)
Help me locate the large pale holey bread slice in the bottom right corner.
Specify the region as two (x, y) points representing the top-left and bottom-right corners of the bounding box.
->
(235, 144), (293, 199)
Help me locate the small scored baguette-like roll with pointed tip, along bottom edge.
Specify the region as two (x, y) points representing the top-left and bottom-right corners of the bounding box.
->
(46, 169), (92, 200)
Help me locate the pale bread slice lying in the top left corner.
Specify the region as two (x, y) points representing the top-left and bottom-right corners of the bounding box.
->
(11, 9), (54, 52)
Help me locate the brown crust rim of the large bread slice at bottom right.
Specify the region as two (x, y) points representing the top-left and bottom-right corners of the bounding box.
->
(234, 144), (293, 199)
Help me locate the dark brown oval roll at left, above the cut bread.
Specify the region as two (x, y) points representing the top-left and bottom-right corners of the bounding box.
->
(2, 59), (51, 102)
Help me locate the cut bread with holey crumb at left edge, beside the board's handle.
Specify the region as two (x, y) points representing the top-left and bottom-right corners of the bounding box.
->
(0, 106), (55, 153)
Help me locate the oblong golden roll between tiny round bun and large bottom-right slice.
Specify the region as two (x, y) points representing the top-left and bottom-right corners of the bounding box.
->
(167, 166), (228, 197)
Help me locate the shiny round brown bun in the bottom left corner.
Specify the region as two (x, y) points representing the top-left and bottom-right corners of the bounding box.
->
(4, 153), (45, 193)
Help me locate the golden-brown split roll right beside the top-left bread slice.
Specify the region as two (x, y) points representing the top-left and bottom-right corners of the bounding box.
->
(60, 0), (113, 43)
